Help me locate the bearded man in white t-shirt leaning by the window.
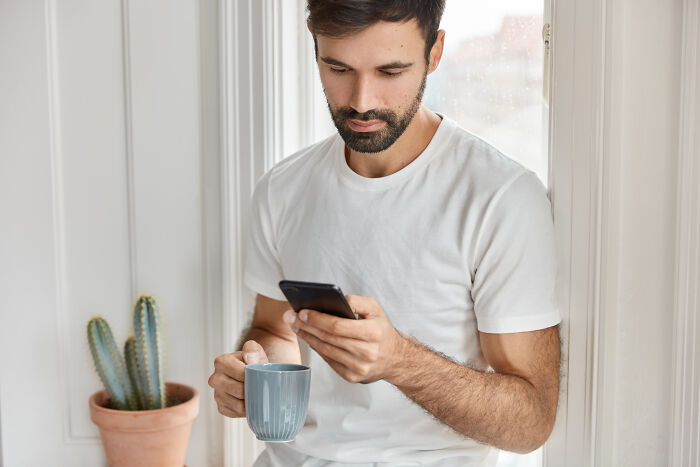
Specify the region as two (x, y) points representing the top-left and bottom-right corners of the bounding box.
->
(209, 0), (560, 466)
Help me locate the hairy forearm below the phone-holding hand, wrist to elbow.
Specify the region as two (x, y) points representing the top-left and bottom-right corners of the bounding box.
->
(387, 336), (553, 453)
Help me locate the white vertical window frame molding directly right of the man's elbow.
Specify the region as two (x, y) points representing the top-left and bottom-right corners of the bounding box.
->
(544, 0), (619, 467)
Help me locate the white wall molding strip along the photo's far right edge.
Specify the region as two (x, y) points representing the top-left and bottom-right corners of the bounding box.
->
(669, 0), (700, 466)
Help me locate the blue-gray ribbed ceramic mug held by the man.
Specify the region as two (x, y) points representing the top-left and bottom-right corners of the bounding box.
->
(244, 363), (311, 442)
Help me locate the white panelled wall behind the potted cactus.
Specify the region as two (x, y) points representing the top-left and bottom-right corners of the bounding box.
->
(0, 0), (220, 467)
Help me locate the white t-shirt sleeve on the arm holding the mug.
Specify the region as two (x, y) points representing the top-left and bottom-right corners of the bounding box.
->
(243, 172), (286, 300)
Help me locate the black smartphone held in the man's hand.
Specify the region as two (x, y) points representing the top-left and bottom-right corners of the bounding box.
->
(279, 280), (358, 319)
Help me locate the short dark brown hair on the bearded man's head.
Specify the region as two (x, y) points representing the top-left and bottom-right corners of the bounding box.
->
(306, 0), (445, 63)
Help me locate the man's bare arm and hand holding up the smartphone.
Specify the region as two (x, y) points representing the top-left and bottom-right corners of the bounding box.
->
(285, 295), (559, 453)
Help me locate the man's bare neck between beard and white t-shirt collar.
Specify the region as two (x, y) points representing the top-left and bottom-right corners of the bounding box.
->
(345, 105), (441, 178)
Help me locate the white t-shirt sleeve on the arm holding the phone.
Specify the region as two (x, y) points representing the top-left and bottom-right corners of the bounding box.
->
(471, 171), (561, 334)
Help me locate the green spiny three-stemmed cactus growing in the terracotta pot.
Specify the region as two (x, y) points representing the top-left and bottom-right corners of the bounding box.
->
(87, 295), (168, 410)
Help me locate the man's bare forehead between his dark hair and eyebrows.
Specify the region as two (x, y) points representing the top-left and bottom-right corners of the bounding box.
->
(316, 19), (425, 68)
